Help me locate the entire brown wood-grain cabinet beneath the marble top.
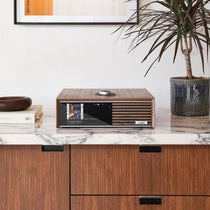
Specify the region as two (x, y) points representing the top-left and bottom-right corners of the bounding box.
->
(0, 145), (210, 210)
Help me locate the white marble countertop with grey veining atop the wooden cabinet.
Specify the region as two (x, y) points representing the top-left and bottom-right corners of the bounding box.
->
(0, 109), (210, 145)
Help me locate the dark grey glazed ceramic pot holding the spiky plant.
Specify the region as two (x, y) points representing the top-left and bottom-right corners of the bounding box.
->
(170, 78), (210, 116)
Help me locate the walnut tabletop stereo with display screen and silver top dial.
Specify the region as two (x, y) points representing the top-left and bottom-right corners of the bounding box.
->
(56, 89), (155, 128)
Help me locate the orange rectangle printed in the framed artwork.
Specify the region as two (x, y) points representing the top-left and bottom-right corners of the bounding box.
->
(25, 0), (53, 15)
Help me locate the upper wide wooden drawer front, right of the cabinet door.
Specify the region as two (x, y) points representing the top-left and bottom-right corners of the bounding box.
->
(71, 145), (210, 195)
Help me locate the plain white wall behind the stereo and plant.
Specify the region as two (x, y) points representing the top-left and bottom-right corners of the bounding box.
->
(0, 0), (210, 108)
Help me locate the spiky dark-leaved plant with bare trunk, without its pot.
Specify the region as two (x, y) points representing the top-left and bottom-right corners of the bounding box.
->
(115, 0), (210, 79)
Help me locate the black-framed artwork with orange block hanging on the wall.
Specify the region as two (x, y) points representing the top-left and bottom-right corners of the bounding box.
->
(14, 0), (138, 24)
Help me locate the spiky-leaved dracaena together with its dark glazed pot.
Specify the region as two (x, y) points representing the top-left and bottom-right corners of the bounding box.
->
(115, 0), (210, 116)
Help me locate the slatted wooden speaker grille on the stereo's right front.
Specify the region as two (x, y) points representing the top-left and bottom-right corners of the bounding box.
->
(112, 101), (153, 125)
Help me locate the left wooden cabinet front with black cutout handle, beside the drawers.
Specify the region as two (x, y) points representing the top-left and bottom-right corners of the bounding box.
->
(0, 146), (70, 210)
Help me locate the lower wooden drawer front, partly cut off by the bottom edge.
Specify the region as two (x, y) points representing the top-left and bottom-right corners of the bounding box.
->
(71, 196), (210, 210)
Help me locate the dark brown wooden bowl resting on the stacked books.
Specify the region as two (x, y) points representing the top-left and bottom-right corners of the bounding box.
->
(0, 96), (32, 111)
